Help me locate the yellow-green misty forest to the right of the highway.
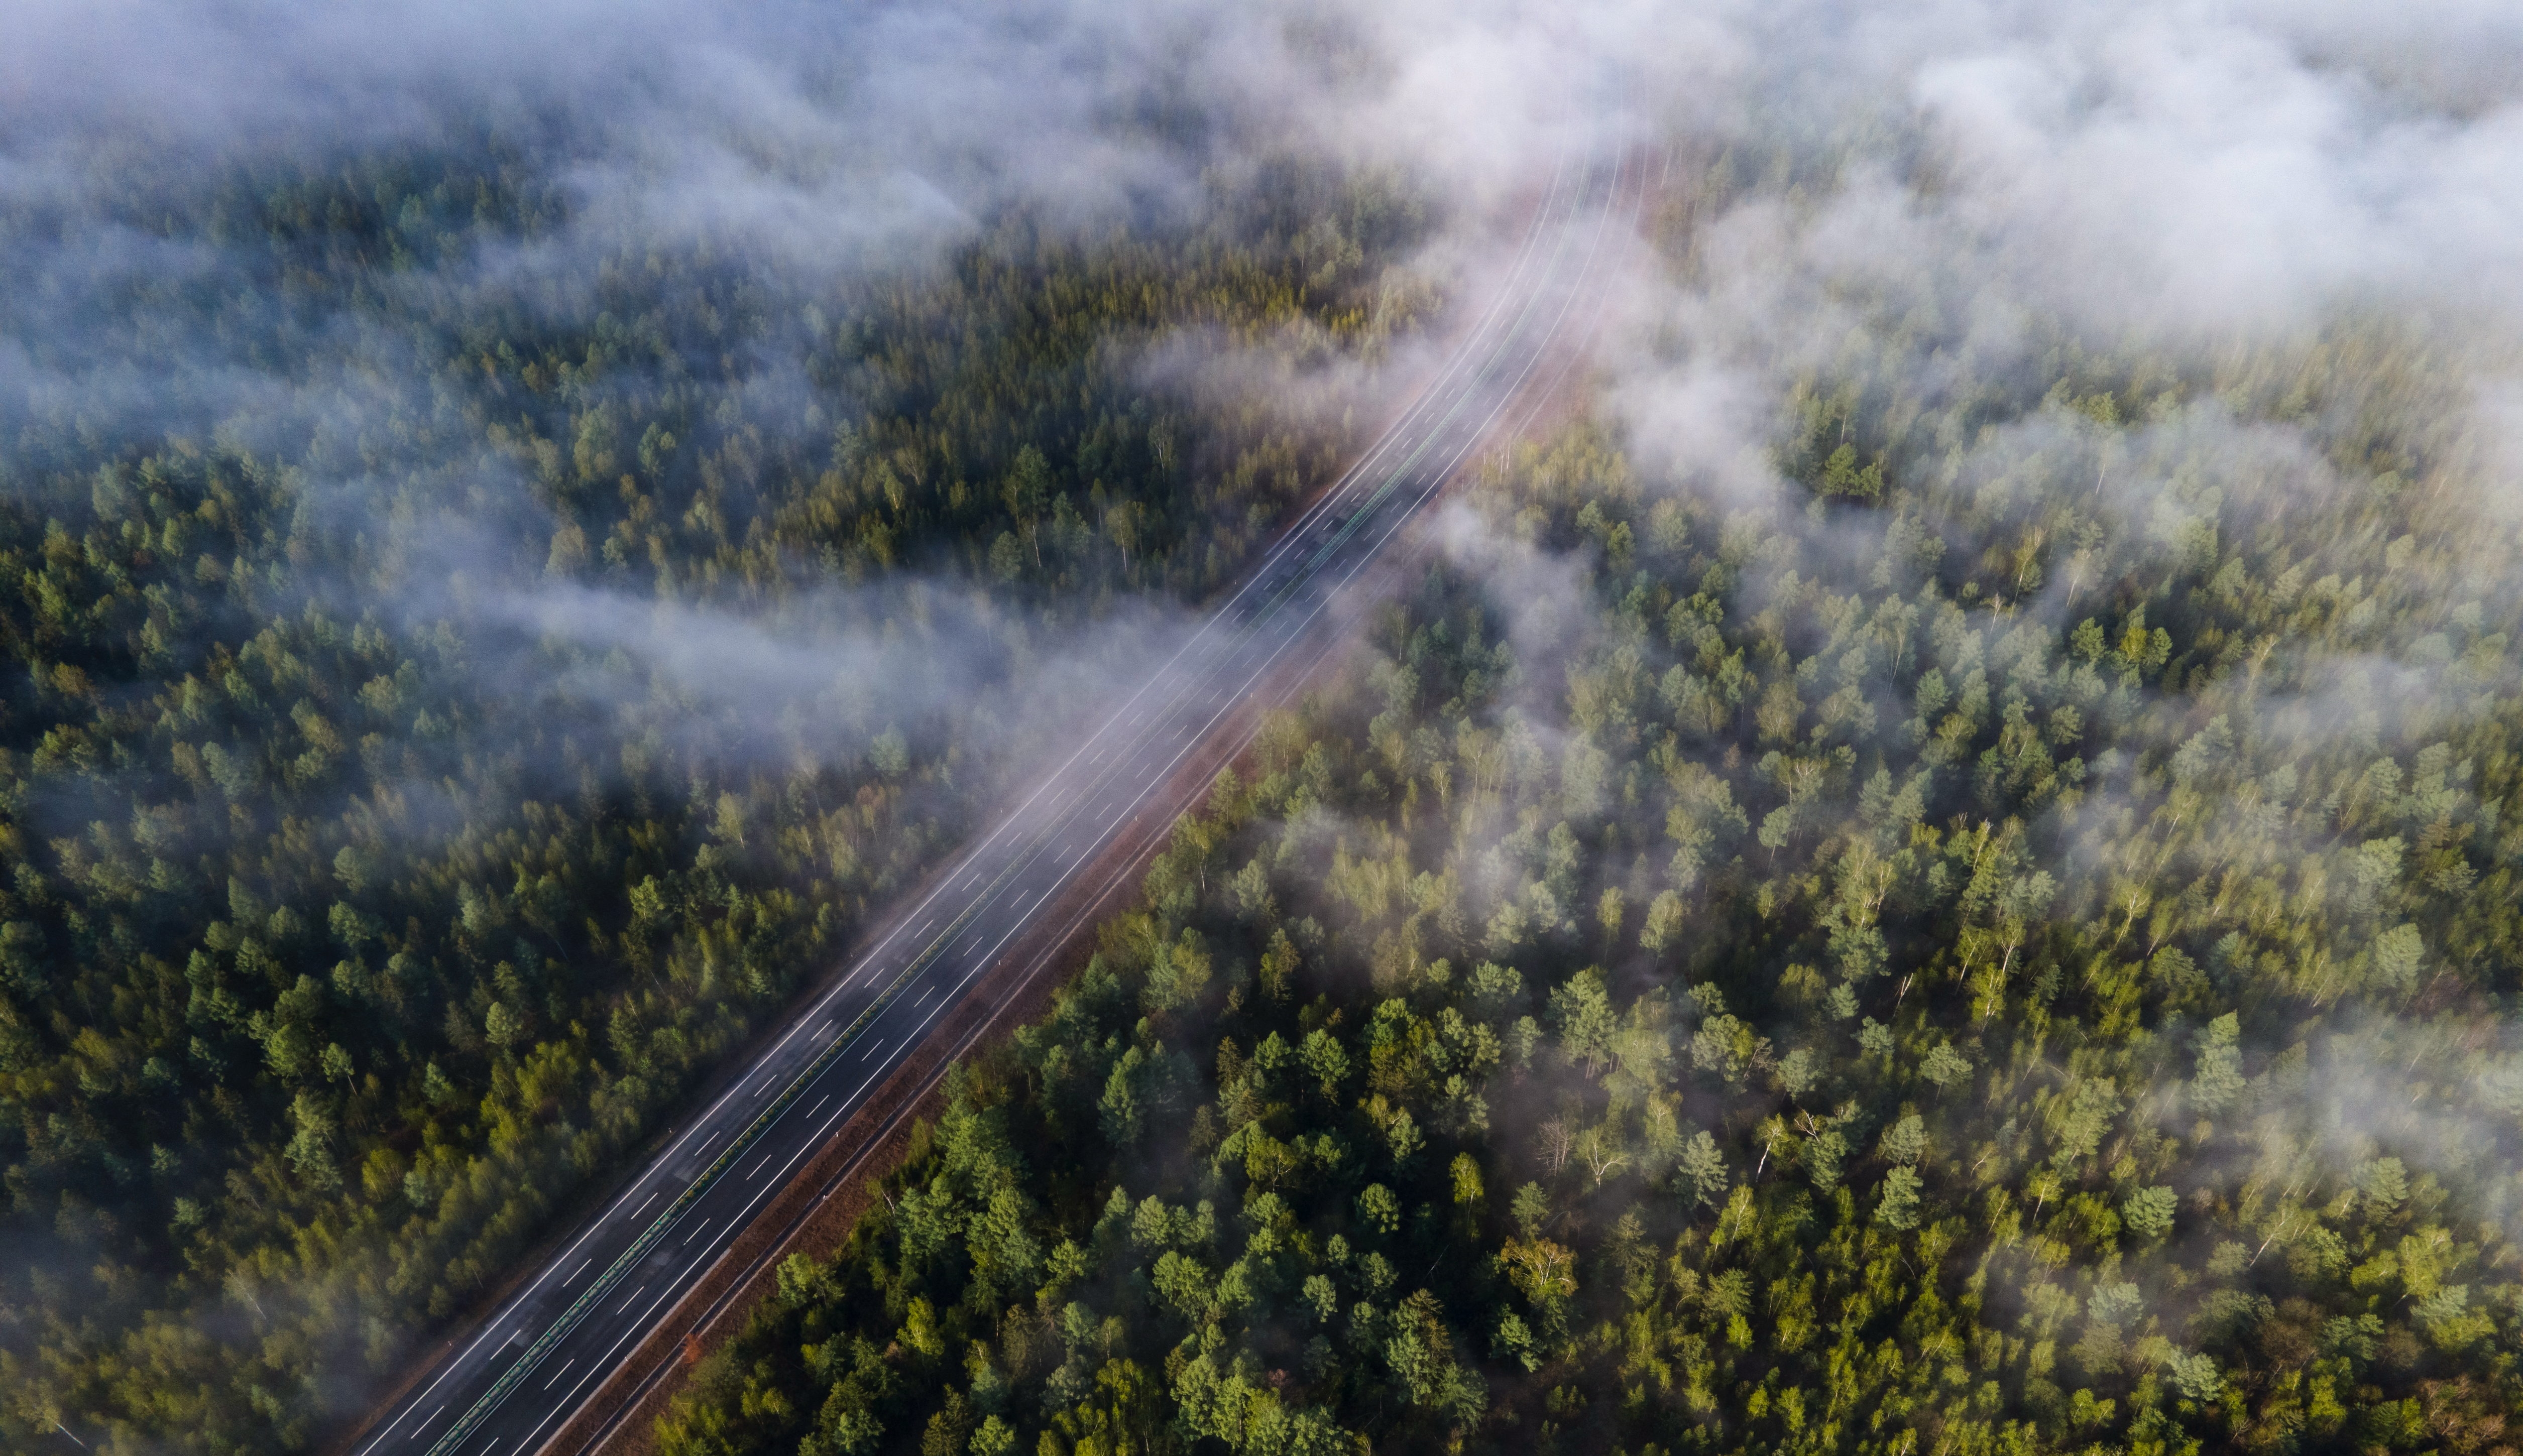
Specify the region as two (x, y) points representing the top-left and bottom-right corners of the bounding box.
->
(661, 315), (2523, 1456)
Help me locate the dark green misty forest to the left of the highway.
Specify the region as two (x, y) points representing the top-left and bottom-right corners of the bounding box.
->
(0, 134), (1433, 1453)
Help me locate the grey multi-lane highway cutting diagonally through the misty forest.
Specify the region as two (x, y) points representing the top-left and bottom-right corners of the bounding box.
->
(353, 145), (1643, 1456)
